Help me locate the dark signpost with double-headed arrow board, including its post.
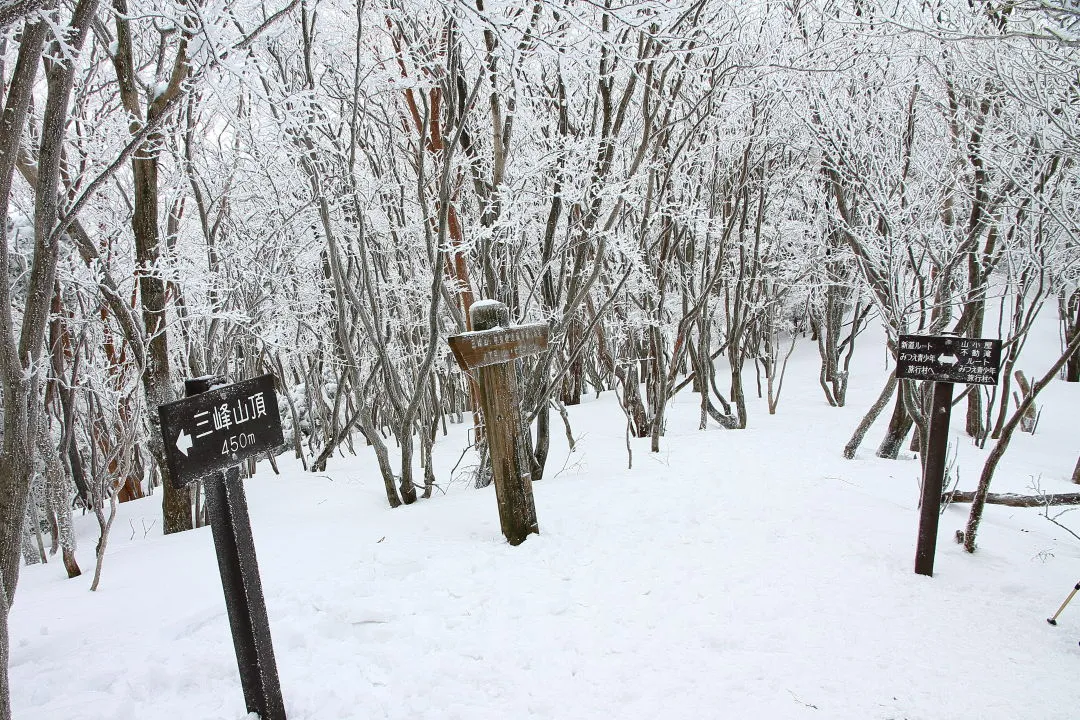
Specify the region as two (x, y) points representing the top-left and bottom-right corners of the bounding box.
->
(896, 335), (1001, 576)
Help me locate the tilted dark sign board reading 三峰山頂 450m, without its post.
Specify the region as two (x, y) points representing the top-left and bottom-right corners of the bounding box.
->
(158, 375), (285, 488)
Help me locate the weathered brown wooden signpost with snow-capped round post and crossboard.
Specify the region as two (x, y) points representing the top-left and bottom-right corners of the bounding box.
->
(448, 300), (550, 545)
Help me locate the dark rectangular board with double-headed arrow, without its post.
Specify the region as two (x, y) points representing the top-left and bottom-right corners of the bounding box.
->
(896, 335), (1001, 385)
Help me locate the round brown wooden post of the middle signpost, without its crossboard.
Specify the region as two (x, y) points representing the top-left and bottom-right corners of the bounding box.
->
(469, 301), (540, 545)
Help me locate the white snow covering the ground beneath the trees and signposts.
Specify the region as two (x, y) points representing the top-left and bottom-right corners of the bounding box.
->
(11, 313), (1080, 720)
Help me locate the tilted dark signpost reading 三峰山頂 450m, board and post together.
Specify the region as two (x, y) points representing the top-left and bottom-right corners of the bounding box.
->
(158, 375), (285, 720)
